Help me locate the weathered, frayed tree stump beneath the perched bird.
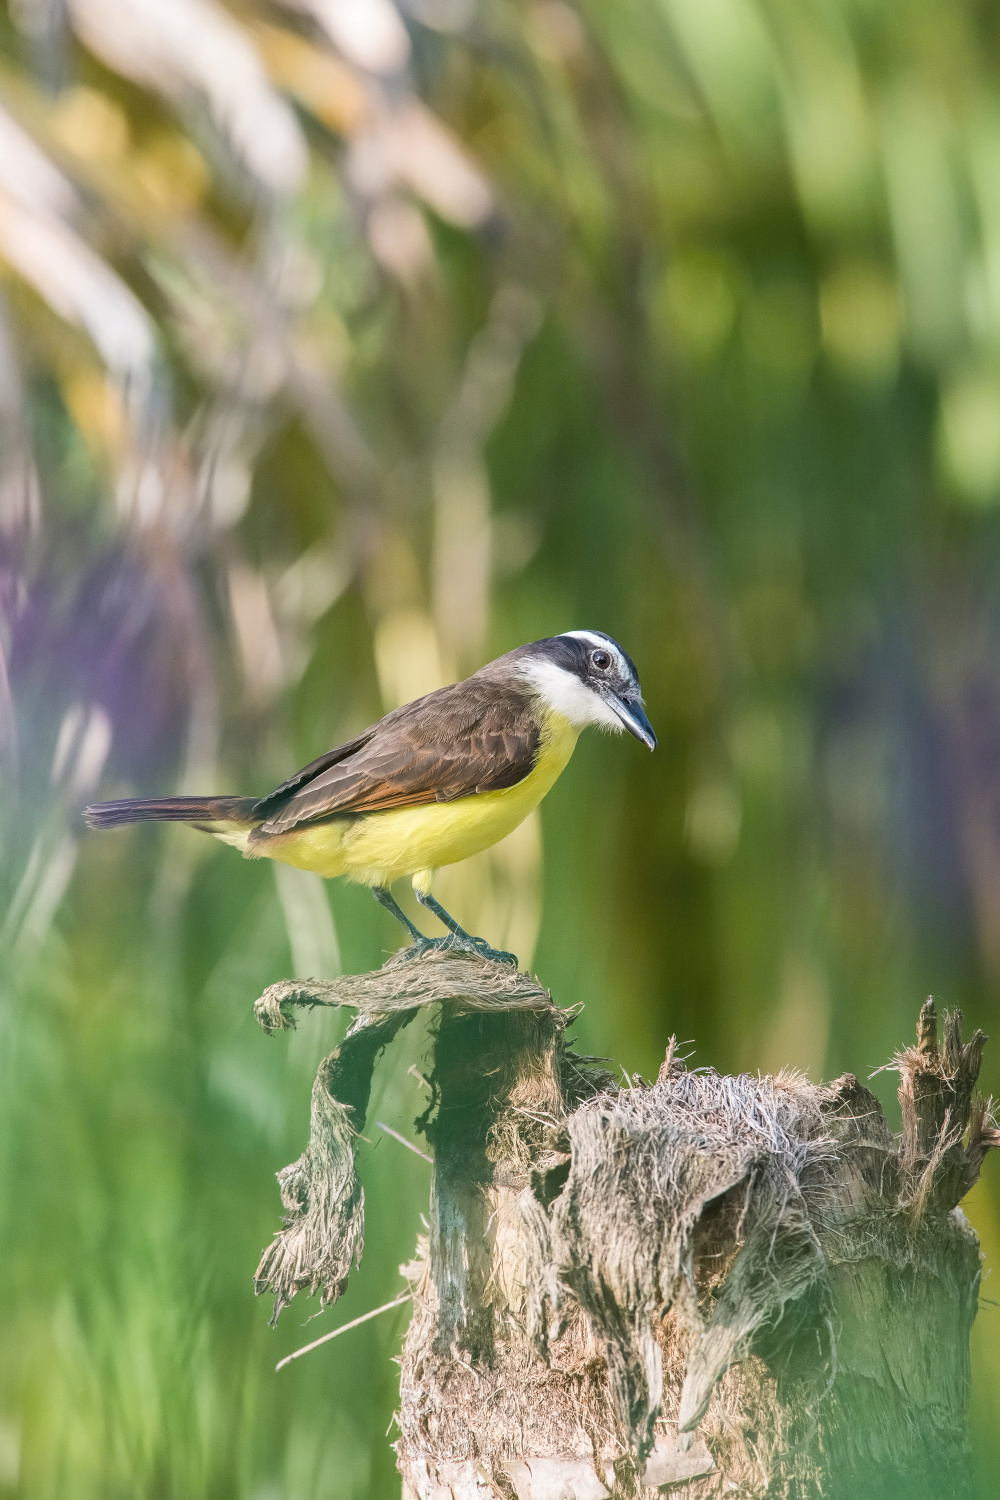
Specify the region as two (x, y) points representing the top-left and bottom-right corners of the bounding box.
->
(256, 951), (1000, 1500)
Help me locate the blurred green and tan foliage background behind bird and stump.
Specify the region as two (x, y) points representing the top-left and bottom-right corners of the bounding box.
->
(0, 0), (1000, 1500)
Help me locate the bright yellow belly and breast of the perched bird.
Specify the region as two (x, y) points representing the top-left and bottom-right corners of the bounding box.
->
(252, 714), (579, 888)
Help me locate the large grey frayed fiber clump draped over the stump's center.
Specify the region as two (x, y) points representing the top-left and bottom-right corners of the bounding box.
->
(523, 1070), (835, 1460)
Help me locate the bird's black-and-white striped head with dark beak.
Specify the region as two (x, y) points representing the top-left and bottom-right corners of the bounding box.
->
(511, 630), (657, 750)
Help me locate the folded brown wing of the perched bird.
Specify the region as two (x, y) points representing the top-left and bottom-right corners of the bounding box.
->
(258, 678), (538, 834)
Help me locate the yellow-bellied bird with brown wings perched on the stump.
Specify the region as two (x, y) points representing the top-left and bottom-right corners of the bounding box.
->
(84, 630), (657, 965)
